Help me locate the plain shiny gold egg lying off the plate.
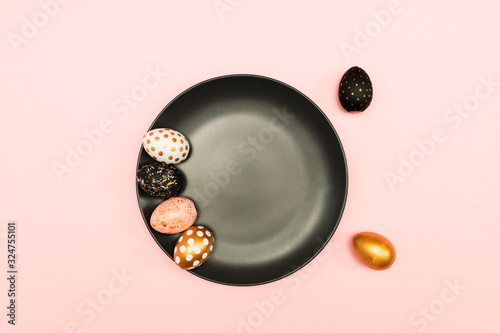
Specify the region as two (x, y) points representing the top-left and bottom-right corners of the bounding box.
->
(352, 232), (396, 270)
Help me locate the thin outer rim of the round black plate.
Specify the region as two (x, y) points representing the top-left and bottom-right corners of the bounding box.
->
(135, 73), (349, 287)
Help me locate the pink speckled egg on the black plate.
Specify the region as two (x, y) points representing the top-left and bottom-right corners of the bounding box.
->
(150, 197), (198, 234)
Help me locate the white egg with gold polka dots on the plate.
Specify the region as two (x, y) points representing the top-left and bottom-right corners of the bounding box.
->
(142, 128), (191, 164)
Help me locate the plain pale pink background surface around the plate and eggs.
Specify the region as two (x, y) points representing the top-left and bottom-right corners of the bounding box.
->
(0, 0), (500, 333)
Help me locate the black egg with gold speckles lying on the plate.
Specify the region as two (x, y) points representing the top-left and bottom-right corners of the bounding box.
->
(136, 163), (185, 199)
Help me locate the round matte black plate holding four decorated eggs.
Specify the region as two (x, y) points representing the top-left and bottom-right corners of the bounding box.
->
(137, 75), (347, 286)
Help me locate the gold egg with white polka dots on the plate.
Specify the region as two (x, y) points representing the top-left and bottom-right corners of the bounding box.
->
(174, 226), (214, 270)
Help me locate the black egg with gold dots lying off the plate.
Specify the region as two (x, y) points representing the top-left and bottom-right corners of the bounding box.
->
(339, 67), (373, 111)
